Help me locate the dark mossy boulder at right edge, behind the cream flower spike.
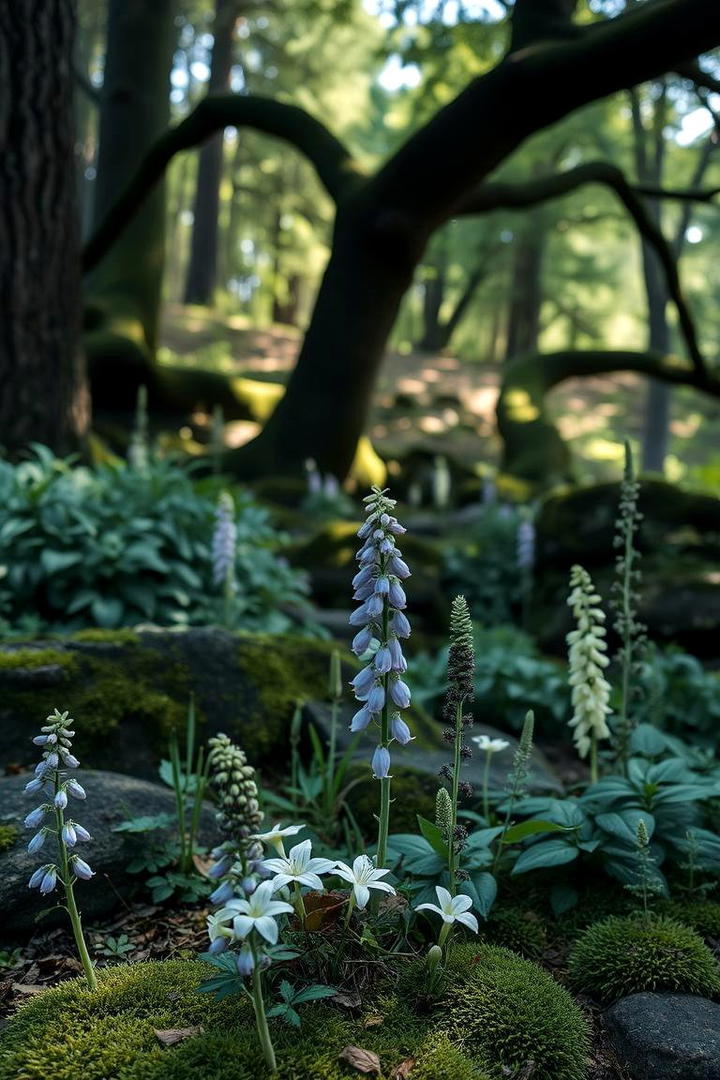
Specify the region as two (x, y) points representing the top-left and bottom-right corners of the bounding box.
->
(531, 478), (720, 660)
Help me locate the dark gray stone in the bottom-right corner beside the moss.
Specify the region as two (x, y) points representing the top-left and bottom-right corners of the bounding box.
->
(604, 994), (720, 1080)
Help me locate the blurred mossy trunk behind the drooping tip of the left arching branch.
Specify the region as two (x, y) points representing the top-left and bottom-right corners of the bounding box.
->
(87, 0), (177, 367)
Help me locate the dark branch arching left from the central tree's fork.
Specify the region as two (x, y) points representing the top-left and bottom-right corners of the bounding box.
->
(83, 94), (358, 272)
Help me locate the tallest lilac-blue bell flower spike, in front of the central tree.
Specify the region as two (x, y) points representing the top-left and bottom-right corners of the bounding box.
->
(350, 487), (412, 780)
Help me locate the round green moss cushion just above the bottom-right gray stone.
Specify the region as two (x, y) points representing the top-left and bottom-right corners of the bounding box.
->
(570, 916), (720, 1002)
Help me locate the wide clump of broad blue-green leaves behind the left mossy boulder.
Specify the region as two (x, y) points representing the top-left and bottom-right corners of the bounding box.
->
(0, 445), (308, 633)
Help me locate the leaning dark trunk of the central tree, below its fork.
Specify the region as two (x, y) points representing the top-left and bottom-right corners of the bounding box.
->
(228, 198), (429, 476)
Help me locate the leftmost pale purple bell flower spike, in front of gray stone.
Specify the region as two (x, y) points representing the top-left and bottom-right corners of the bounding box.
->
(25, 710), (94, 895)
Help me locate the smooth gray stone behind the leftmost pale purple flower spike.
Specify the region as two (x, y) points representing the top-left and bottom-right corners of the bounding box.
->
(0, 769), (217, 941)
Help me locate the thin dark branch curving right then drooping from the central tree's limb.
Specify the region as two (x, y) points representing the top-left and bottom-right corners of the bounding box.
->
(458, 161), (707, 375)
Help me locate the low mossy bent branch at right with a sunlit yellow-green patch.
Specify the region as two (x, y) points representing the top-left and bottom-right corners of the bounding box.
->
(495, 349), (720, 488)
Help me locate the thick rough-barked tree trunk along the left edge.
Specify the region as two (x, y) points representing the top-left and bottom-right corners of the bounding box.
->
(0, 0), (90, 454)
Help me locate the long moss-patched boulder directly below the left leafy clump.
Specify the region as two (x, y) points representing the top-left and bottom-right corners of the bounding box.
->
(0, 626), (356, 779)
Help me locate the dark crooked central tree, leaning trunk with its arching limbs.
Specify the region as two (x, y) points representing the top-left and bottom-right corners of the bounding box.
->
(81, 0), (720, 476)
